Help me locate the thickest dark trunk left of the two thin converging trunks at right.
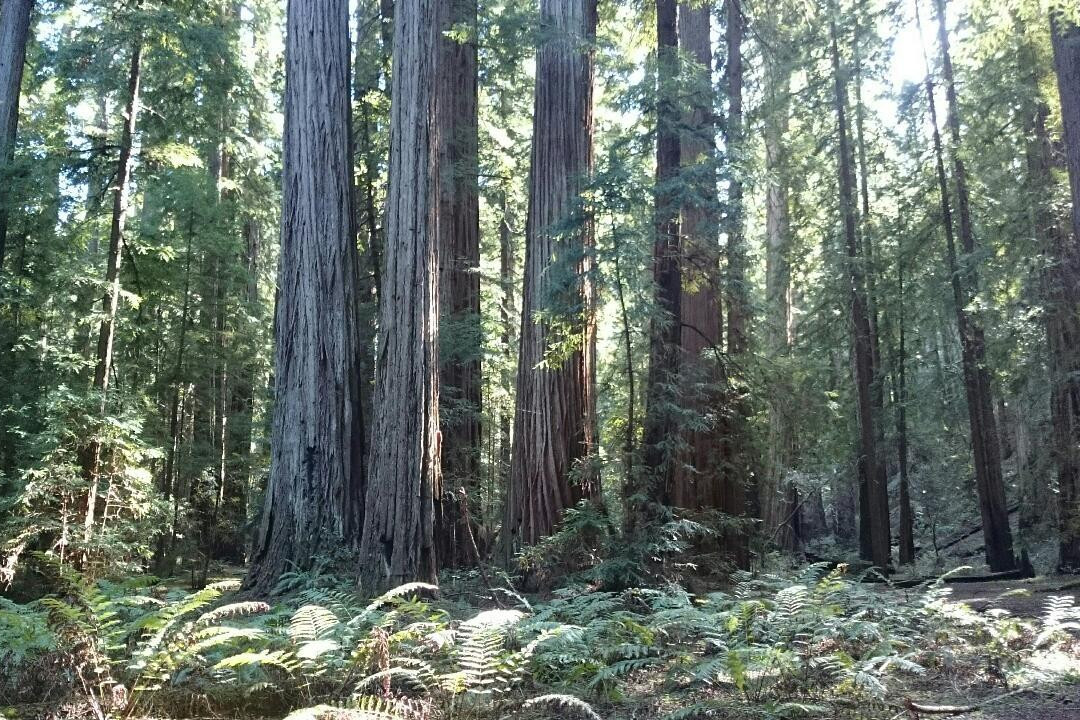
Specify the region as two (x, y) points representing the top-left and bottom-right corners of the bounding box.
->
(829, 12), (891, 571)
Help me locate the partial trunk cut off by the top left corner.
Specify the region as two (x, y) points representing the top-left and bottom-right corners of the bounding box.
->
(0, 0), (33, 270)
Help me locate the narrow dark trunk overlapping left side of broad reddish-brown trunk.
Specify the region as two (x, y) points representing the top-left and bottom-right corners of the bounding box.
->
(626, 0), (683, 524)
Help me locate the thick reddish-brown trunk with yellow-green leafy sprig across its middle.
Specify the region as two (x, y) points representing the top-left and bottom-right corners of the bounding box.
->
(502, 0), (597, 561)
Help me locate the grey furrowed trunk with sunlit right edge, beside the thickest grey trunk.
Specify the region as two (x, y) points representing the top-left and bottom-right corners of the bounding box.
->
(360, 0), (442, 593)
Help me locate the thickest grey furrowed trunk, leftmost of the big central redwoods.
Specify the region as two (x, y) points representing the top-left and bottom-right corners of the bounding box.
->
(244, 0), (364, 593)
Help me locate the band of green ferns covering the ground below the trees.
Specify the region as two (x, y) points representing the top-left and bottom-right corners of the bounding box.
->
(0, 565), (1080, 720)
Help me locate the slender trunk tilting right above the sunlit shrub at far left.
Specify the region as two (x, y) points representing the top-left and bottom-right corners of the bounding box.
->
(81, 40), (143, 548)
